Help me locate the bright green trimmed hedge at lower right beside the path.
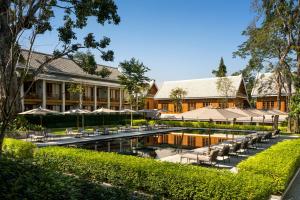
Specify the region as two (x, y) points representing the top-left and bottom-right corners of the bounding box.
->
(237, 139), (300, 193)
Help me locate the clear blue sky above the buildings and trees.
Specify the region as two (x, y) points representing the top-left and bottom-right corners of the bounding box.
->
(23, 0), (254, 83)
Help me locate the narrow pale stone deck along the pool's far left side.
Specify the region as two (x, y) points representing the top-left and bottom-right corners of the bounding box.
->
(35, 127), (187, 147)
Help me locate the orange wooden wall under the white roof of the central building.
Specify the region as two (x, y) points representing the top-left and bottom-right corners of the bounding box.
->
(156, 98), (246, 113)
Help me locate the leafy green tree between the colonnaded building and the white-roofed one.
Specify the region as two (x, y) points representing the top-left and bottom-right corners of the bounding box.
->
(118, 58), (150, 110)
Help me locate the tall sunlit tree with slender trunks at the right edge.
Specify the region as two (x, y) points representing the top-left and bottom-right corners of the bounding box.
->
(234, 0), (300, 131)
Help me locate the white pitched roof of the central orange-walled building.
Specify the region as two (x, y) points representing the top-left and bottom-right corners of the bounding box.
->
(154, 75), (246, 100)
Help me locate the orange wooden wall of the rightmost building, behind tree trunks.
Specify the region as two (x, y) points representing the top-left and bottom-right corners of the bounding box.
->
(256, 96), (287, 112)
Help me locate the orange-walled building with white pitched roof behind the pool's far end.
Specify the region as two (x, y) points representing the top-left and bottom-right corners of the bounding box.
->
(154, 75), (249, 113)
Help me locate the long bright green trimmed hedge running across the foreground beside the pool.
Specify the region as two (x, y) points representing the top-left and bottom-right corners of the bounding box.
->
(34, 147), (271, 199)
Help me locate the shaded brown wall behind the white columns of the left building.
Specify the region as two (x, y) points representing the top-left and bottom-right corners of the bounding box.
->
(23, 80), (126, 112)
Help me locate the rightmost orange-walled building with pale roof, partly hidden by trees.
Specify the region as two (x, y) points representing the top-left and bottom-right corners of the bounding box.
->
(251, 73), (294, 112)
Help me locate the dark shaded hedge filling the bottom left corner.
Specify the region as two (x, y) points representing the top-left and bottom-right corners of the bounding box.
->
(0, 159), (144, 200)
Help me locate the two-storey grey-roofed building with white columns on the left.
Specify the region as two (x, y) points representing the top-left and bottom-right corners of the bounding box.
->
(18, 50), (128, 112)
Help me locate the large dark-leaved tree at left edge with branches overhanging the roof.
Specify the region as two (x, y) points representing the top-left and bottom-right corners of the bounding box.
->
(0, 0), (120, 153)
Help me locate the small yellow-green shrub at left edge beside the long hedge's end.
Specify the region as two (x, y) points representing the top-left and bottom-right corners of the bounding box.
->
(2, 138), (36, 159)
